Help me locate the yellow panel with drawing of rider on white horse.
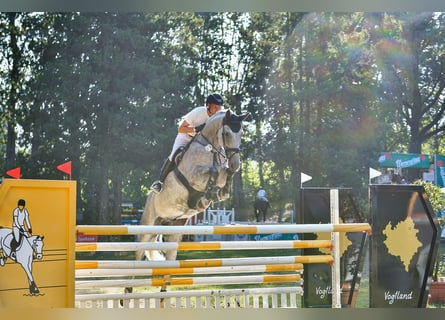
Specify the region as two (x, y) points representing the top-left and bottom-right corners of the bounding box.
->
(0, 179), (76, 308)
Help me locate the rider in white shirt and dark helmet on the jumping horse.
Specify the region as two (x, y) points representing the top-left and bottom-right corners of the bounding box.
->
(150, 93), (223, 193)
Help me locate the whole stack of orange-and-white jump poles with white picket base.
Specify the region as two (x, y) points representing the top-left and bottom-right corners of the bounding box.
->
(76, 223), (370, 308)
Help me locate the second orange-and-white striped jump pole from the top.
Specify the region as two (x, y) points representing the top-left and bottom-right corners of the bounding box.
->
(76, 240), (332, 252)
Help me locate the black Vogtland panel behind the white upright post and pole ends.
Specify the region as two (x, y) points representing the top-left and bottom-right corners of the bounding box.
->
(297, 188), (367, 308)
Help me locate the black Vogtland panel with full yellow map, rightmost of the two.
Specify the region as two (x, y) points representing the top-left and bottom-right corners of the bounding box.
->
(369, 185), (440, 308)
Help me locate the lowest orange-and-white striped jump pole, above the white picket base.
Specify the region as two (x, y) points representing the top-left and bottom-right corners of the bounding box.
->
(76, 274), (301, 289)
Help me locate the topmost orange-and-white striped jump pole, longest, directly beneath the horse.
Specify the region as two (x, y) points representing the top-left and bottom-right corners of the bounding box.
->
(76, 223), (371, 235)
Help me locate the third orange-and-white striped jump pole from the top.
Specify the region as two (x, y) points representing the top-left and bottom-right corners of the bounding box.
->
(75, 255), (333, 270)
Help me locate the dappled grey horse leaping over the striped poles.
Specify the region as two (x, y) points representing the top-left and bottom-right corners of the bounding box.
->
(136, 110), (249, 260)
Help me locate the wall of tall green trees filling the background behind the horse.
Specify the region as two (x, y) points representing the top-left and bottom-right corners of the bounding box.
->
(0, 12), (445, 223)
